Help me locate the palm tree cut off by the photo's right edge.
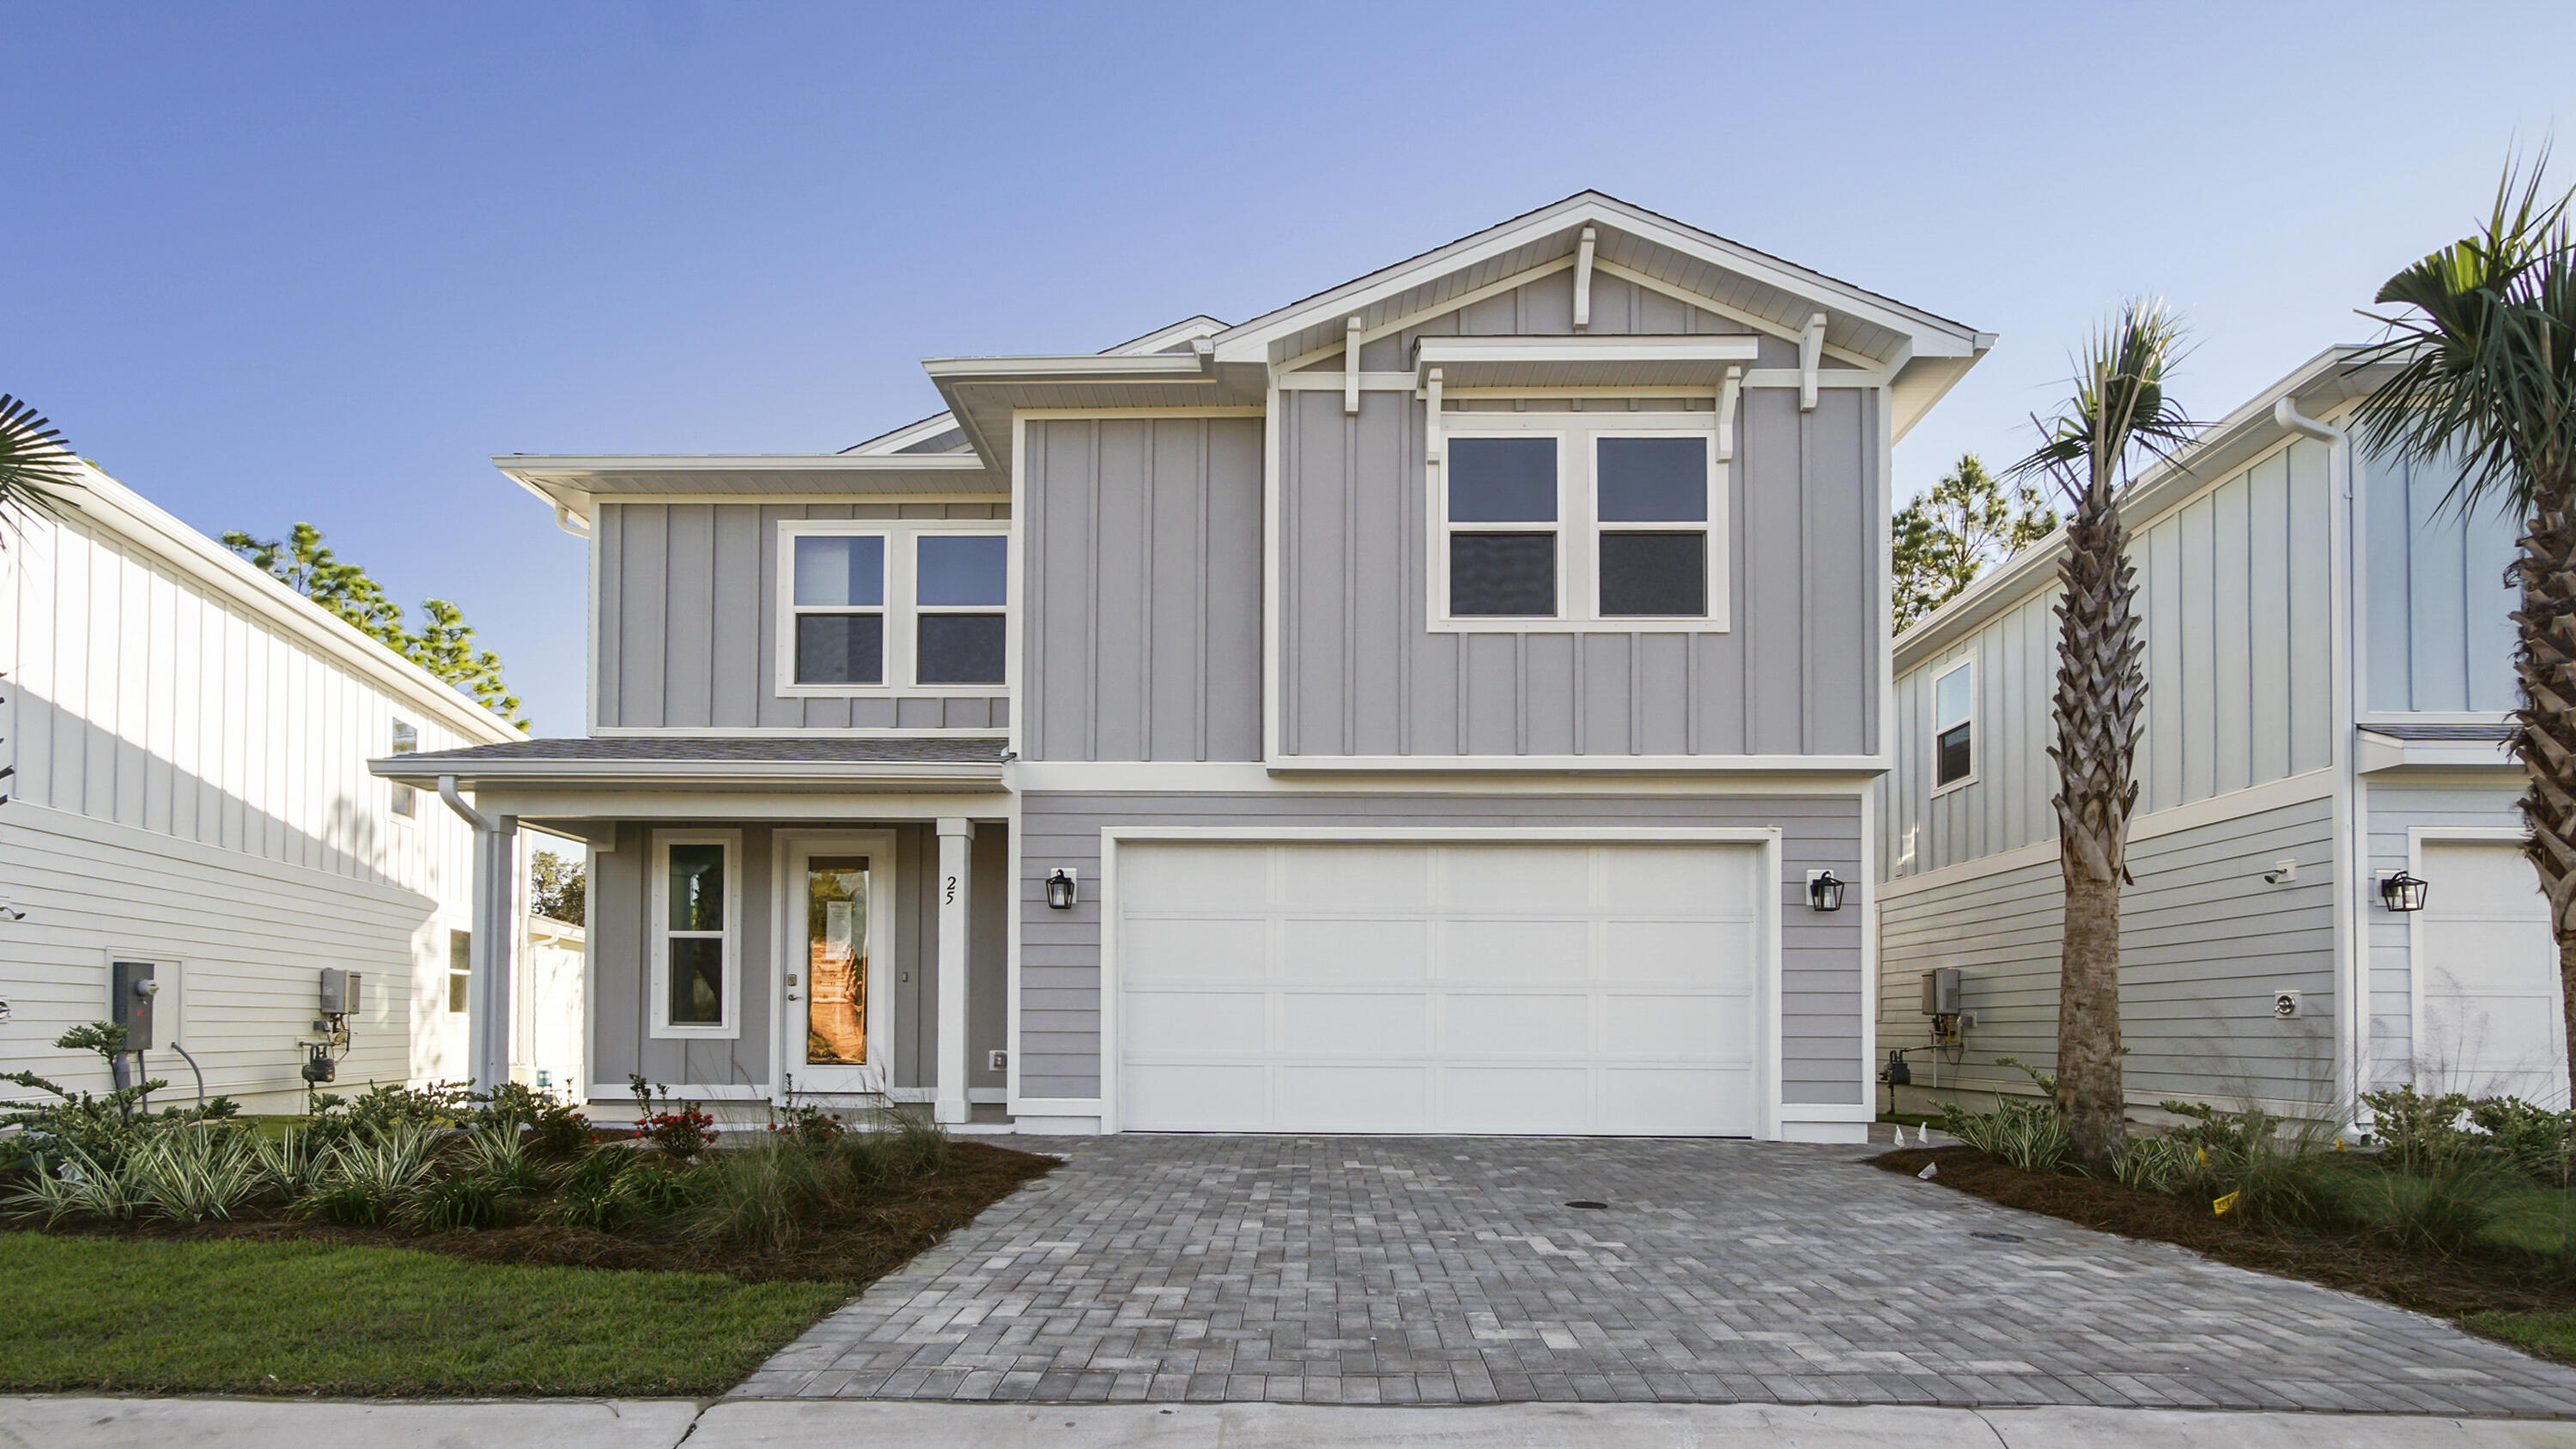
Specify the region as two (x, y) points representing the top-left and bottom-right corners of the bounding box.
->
(2354, 152), (2576, 1106)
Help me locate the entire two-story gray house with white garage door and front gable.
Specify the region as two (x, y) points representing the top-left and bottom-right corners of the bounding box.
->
(376, 193), (1991, 1140)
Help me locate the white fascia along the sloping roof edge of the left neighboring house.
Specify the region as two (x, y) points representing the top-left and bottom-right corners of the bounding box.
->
(49, 464), (526, 743)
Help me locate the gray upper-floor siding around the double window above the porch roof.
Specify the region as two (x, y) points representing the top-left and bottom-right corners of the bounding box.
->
(590, 500), (1010, 731)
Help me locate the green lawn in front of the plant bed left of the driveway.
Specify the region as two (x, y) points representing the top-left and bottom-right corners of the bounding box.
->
(0, 1233), (850, 1395)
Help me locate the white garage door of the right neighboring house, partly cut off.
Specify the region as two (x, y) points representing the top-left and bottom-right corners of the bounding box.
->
(2416, 841), (2568, 1106)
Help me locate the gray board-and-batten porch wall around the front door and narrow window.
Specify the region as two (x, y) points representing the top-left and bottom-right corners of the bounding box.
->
(590, 818), (1010, 1088)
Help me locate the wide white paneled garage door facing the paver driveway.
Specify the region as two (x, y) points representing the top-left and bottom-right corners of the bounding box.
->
(1115, 841), (1762, 1135)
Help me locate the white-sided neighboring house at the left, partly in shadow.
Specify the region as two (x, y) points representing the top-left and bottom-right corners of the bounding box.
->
(0, 469), (582, 1109)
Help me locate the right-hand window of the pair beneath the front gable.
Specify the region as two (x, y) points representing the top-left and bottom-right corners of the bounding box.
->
(1592, 438), (1708, 618)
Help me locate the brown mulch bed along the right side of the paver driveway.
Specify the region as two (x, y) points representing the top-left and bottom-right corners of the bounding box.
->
(1870, 1148), (2576, 1318)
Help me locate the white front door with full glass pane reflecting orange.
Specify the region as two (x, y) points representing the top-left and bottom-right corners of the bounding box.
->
(775, 831), (896, 1091)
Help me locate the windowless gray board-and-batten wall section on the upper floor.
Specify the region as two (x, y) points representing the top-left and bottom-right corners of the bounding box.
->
(1020, 417), (1262, 759)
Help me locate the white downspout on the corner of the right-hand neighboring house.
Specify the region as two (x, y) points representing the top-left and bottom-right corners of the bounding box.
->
(2272, 397), (2370, 1135)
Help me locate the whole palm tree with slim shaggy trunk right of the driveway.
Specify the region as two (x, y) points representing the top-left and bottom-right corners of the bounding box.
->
(2012, 301), (2195, 1168)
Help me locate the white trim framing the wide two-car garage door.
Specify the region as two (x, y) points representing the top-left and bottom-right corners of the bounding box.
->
(1097, 826), (1783, 1140)
